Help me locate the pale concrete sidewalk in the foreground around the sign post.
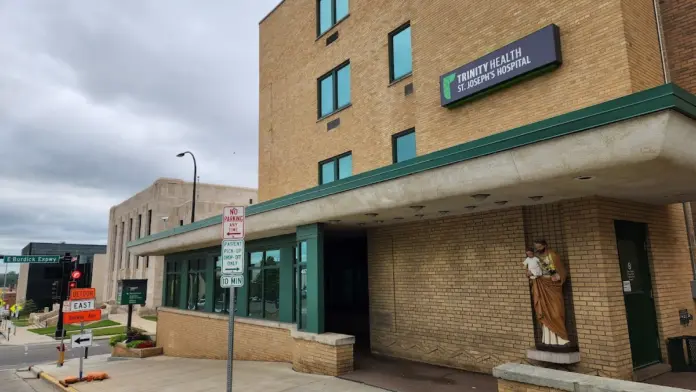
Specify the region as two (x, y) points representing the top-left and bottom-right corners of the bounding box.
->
(33, 355), (385, 392)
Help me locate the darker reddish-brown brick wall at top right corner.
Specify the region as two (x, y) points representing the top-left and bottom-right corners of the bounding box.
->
(660, 0), (696, 94)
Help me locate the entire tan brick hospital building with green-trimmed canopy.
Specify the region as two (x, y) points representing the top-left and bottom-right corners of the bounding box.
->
(128, 0), (696, 378)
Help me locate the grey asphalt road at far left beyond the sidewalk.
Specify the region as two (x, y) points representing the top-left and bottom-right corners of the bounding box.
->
(0, 340), (111, 370)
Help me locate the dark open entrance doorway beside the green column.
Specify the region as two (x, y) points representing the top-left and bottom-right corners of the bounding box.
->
(324, 228), (370, 349)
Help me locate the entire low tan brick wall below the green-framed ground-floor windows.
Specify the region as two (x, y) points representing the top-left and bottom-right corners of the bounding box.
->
(157, 308), (353, 376)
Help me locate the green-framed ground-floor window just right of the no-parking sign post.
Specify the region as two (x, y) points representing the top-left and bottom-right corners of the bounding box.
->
(248, 250), (280, 321)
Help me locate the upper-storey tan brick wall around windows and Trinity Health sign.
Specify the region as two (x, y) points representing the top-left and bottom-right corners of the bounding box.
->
(259, 0), (648, 201)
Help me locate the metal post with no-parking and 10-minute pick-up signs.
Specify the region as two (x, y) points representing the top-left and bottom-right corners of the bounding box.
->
(220, 206), (246, 392)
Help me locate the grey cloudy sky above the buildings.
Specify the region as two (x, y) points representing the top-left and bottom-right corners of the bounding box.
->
(0, 0), (279, 272)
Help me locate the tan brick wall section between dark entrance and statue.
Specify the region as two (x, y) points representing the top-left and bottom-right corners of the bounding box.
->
(368, 208), (534, 372)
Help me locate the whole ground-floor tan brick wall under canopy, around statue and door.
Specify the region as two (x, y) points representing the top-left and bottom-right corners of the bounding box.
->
(368, 198), (696, 379)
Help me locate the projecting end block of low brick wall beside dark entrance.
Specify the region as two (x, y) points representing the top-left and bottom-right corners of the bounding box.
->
(292, 339), (353, 376)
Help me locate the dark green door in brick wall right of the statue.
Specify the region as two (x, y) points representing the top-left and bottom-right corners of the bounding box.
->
(614, 221), (662, 369)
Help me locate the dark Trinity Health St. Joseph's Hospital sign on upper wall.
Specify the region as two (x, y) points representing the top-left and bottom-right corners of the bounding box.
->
(440, 24), (563, 107)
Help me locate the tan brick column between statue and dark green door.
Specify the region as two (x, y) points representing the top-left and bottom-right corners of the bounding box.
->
(562, 198), (633, 379)
